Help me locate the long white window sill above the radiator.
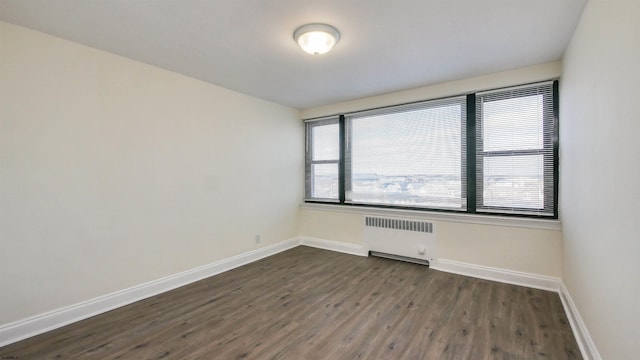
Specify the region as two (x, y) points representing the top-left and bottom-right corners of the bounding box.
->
(300, 203), (562, 231)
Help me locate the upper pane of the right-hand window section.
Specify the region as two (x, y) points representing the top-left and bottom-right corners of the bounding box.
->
(482, 95), (544, 151)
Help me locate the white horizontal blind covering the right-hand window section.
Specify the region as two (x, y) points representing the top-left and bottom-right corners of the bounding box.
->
(476, 83), (556, 216)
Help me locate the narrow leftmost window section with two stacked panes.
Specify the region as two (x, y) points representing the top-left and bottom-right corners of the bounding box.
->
(305, 117), (340, 201)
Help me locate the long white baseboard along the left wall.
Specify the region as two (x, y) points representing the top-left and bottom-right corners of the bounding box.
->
(0, 238), (301, 347)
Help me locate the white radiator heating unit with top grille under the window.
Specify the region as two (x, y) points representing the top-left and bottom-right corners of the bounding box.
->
(364, 216), (437, 265)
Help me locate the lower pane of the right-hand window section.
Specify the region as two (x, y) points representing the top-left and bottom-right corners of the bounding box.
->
(483, 155), (544, 209)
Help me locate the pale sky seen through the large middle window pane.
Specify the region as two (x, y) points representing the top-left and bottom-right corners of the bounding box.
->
(350, 104), (462, 177)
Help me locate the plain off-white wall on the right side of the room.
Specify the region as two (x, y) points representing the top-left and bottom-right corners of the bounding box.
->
(560, 0), (640, 359)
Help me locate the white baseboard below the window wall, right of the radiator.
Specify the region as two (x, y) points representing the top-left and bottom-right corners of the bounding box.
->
(429, 259), (561, 292)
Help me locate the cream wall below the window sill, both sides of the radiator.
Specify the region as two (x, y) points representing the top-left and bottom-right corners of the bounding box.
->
(300, 208), (562, 278)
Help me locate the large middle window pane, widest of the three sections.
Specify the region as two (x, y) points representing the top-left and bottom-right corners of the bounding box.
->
(346, 103), (466, 209)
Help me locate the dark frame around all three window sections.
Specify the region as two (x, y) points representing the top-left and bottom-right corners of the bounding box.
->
(304, 79), (559, 220)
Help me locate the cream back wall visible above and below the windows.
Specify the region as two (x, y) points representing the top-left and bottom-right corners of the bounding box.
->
(300, 62), (562, 277)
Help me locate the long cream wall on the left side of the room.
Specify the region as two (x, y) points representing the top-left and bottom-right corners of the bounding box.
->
(0, 22), (304, 325)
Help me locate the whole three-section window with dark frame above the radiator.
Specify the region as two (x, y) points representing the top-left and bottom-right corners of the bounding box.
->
(306, 82), (557, 217)
